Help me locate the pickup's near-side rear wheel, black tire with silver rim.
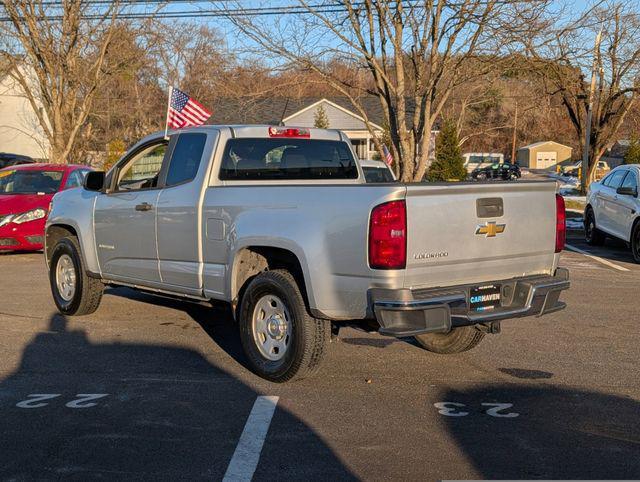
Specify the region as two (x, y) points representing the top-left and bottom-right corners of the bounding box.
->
(239, 270), (331, 383)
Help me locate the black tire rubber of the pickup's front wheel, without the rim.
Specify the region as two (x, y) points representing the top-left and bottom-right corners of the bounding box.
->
(49, 236), (104, 316)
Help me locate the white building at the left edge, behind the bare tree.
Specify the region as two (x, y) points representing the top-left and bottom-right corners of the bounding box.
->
(0, 64), (49, 160)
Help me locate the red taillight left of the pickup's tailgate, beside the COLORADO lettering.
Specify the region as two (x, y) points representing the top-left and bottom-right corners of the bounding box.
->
(369, 201), (407, 269)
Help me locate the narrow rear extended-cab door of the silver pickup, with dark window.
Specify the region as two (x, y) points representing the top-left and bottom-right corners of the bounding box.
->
(157, 130), (218, 295)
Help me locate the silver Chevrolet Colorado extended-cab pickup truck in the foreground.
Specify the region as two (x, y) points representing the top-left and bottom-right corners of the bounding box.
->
(45, 126), (569, 382)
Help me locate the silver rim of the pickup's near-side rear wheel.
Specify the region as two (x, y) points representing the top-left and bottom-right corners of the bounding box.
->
(251, 295), (291, 361)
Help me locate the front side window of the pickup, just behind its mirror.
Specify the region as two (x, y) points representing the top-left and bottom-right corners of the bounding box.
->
(116, 142), (167, 191)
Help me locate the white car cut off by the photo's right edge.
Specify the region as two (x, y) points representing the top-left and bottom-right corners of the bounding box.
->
(584, 164), (640, 263)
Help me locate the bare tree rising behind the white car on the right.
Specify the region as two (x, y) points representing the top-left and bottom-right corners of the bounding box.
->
(530, 0), (640, 186)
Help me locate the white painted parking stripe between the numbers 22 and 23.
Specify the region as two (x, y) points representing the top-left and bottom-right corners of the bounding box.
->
(222, 396), (278, 482)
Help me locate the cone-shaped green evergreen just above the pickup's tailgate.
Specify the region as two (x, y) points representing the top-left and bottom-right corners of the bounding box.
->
(426, 120), (467, 181)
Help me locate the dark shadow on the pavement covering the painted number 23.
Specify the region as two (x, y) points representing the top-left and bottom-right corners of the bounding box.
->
(442, 384), (640, 479)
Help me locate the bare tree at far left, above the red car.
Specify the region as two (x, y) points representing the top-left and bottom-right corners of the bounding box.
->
(0, 0), (118, 163)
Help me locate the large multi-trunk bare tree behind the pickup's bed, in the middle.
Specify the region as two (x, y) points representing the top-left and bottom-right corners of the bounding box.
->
(232, 0), (547, 181)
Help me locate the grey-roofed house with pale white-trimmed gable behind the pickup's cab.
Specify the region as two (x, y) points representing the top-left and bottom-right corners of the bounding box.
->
(209, 96), (438, 159)
